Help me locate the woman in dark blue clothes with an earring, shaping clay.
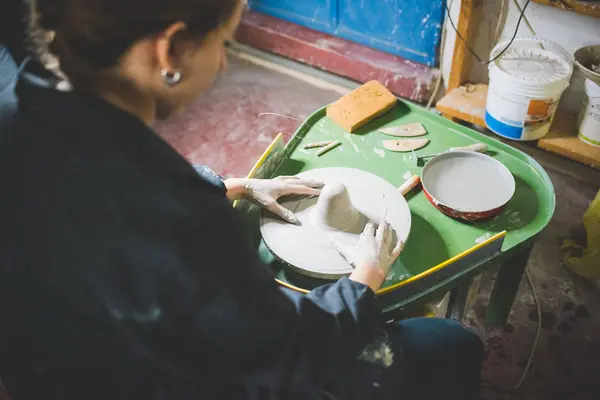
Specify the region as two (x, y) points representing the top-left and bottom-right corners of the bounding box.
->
(0, 0), (482, 400)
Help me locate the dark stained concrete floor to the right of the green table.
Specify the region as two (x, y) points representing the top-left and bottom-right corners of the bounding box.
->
(465, 172), (600, 400)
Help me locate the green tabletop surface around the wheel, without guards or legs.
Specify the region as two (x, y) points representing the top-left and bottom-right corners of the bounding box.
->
(252, 101), (555, 322)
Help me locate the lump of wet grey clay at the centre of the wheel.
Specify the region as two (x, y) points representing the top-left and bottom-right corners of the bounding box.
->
(311, 183), (366, 232)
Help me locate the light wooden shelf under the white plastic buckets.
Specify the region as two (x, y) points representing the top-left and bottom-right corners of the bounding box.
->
(436, 84), (600, 170)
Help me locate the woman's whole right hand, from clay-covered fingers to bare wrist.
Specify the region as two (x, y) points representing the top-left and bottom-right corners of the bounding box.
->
(333, 221), (404, 292)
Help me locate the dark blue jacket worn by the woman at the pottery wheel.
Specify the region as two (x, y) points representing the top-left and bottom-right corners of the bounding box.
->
(0, 63), (380, 400)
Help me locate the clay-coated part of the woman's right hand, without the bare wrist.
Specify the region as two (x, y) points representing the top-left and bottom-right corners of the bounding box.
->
(333, 221), (404, 277)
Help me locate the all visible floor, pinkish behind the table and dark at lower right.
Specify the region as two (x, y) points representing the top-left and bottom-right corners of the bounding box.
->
(0, 54), (600, 400)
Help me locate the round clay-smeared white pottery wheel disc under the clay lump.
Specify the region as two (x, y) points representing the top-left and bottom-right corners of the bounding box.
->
(260, 168), (411, 279)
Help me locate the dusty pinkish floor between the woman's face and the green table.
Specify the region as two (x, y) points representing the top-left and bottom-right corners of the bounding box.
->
(157, 57), (339, 176)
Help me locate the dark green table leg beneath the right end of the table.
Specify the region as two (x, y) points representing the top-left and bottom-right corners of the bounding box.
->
(485, 246), (532, 326)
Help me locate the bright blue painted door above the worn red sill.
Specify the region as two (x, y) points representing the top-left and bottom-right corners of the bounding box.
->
(246, 0), (444, 66)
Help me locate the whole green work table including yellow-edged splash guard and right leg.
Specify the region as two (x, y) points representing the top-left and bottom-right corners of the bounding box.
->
(241, 101), (555, 325)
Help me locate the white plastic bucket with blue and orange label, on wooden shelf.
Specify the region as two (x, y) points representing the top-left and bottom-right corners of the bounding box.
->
(485, 38), (573, 140)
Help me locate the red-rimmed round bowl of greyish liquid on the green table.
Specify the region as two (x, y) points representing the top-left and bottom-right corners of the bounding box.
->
(421, 151), (516, 221)
